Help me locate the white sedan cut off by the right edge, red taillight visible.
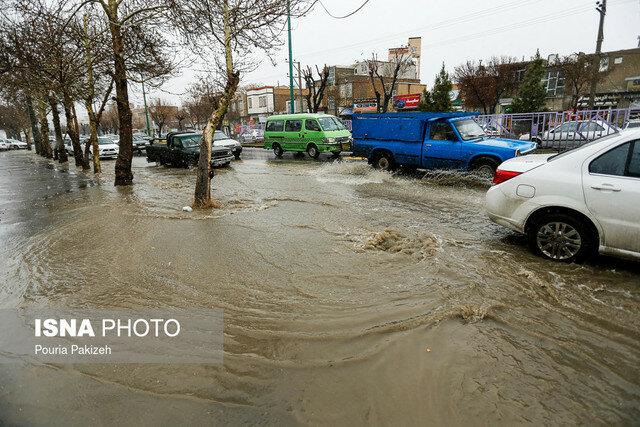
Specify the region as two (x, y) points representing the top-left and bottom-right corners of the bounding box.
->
(486, 129), (640, 262)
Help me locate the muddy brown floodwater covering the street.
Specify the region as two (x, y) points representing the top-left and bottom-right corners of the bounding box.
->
(0, 150), (640, 425)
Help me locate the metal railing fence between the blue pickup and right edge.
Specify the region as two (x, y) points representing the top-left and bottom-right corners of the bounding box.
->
(477, 108), (640, 151)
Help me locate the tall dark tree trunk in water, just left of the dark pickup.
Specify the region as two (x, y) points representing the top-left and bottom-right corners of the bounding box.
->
(106, 0), (133, 185)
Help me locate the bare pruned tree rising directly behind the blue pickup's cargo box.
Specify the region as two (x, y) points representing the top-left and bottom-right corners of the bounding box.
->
(366, 53), (413, 113)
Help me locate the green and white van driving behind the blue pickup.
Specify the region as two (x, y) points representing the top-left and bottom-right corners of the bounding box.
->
(264, 113), (353, 159)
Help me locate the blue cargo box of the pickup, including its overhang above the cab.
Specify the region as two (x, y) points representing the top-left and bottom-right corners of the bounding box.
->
(352, 113), (477, 142)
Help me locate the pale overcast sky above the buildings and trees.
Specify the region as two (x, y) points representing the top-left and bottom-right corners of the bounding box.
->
(133, 0), (640, 108)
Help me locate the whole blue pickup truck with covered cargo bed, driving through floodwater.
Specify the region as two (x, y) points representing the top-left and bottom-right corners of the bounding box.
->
(352, 113), (536, 176)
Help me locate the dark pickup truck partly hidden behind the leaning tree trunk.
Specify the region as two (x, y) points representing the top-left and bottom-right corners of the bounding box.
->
(147, 132), (233, 167)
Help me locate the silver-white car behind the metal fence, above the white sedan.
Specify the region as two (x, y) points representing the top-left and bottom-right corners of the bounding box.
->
(520, 120), (617, 148)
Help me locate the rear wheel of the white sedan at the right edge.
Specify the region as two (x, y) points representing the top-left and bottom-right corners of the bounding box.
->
(528, 213), (596, 262)
